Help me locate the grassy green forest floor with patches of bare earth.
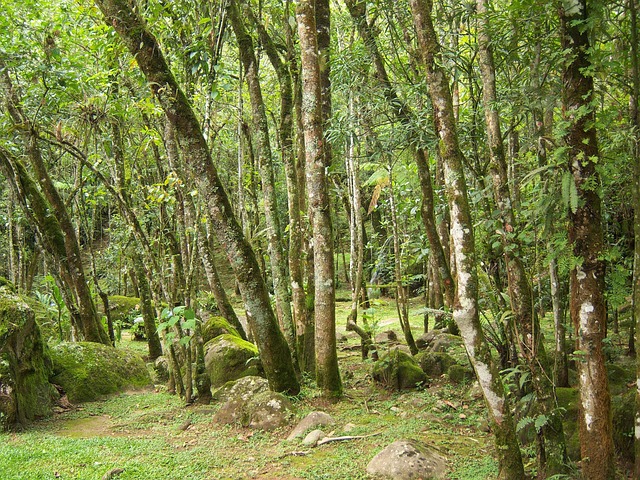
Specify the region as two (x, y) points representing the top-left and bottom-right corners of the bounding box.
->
(0, 294), (628, 480)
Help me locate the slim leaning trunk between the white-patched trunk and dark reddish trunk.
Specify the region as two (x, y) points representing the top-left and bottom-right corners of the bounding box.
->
(477, 0), (568, 479)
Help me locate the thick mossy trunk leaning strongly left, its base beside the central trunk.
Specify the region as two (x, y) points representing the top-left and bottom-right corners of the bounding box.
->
(96, 0), (300, 394)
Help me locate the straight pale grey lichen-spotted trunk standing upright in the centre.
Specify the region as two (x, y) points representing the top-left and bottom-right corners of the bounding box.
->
(296, 0), (342, 396)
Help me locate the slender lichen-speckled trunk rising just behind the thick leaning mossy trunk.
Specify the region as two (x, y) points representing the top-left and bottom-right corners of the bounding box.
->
(227, 0), (297, 366)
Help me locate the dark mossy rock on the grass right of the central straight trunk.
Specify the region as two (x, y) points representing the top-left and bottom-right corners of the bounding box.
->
(372, 349), (427, 390)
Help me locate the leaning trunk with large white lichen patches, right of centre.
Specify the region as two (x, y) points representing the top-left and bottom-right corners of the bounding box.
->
(411, 0), (524, 479)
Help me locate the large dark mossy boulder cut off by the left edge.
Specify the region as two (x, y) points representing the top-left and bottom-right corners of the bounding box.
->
(0, 287), (58, 429)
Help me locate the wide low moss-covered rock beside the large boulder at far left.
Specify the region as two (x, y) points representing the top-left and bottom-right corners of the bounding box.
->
(51, 342), (151, 403)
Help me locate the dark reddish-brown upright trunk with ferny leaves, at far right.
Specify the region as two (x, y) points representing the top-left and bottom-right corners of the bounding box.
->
(560, 0), (615, 480)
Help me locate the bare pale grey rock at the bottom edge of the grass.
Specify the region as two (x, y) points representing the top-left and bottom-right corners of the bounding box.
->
(367, 440), (446, 480)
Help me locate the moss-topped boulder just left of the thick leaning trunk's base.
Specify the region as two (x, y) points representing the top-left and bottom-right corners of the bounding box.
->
(204, 333), (262, 388)
